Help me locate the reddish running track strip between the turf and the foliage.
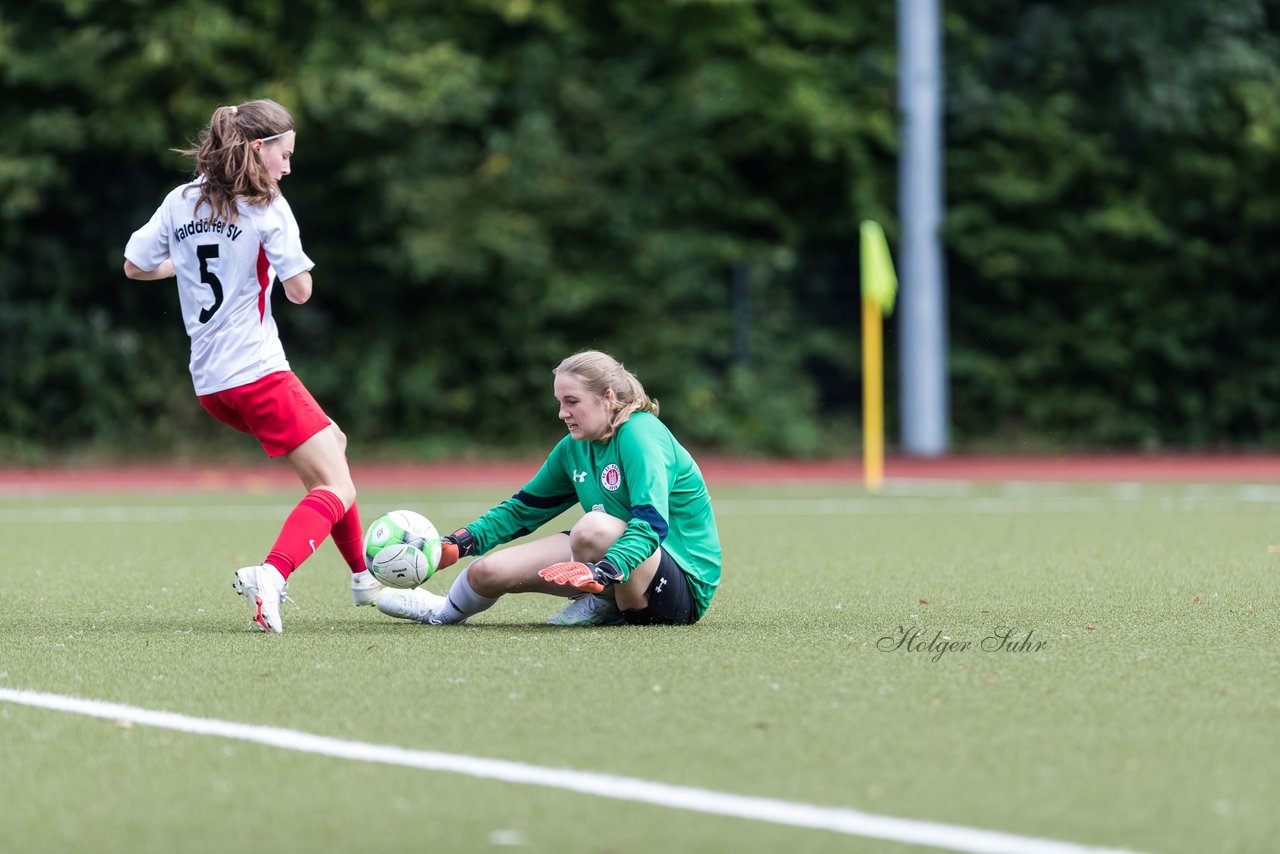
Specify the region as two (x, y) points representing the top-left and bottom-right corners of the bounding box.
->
(0, 456), (1280, 493)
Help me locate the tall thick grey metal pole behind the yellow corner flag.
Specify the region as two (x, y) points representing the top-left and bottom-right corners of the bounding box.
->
(897, 0), (950, 457)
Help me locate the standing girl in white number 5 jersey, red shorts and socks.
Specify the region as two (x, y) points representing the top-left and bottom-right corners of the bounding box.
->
(124, 100), (379, 632)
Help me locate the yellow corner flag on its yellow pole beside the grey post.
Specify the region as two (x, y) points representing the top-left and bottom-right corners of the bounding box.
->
(860, 219), (897, 492)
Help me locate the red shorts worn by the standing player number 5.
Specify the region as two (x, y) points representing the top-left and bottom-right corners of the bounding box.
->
(200, 371), (333, 457)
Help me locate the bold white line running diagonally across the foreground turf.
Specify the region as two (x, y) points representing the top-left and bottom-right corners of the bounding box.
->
(0, 688), (1141, 854)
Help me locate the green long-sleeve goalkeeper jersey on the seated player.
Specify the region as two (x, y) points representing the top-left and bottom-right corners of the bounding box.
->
(467, 412), (721, 617)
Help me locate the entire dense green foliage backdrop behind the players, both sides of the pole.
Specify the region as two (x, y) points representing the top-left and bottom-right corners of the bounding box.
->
(0, 0), (1280, 453)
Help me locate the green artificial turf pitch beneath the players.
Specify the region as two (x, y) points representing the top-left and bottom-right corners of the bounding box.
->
(0, 481), (1280, 854)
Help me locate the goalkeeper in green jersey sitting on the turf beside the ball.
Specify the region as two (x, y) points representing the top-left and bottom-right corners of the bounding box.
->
(378, 351), (721, 626)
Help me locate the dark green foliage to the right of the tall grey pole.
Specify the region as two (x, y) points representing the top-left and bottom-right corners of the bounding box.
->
(947, 1), (1280, 448)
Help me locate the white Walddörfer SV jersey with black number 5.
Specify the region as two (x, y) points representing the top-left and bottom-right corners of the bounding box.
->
(124, 183), (315, 394)
